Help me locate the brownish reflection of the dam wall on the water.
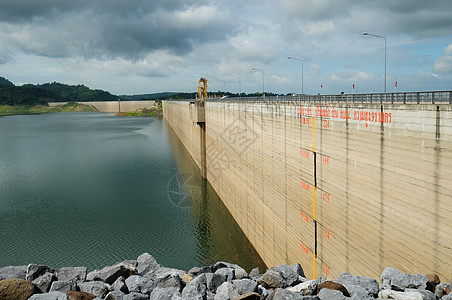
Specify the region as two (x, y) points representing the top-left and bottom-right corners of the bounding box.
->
(165, 121), (266, 271)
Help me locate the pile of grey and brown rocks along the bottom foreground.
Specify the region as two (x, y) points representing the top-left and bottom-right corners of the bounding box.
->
(0, 253), (452, 300)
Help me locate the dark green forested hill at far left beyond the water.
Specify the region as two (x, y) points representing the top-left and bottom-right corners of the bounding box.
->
(0, 77), (118, 105)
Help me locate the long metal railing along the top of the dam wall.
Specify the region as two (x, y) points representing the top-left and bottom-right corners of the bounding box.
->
(167, 91), (452, 104)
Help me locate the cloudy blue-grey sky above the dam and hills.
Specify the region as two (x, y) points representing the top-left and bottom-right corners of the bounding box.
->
(0, 0), (452, 95)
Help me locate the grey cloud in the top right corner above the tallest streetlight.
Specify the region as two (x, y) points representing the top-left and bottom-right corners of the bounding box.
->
(278, 0), (452, 38)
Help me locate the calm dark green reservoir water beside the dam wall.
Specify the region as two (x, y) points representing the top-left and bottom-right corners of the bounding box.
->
(0, 113), (265, 271)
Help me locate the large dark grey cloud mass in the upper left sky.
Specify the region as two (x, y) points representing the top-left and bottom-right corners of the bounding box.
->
(0, 0), (236, 59)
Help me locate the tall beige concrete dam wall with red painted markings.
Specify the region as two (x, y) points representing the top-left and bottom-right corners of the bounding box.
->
(163, 97), (452, 278)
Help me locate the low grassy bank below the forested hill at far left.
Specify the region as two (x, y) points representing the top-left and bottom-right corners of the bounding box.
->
(0, 102), (97, 116)
